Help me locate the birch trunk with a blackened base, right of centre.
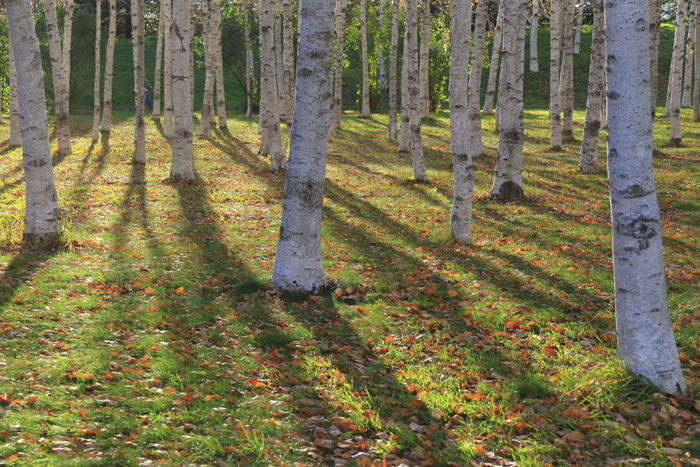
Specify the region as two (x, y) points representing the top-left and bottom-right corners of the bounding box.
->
(491, 0), (527, 200)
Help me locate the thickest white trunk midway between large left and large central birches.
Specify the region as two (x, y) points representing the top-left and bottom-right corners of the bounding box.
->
(172, 0), (195, 180)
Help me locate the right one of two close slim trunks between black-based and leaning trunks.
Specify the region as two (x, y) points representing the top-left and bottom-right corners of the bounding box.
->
(559, 0), (575, 142)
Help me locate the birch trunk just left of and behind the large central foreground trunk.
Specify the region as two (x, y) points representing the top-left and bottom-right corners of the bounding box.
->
(258, 0), (286, 172)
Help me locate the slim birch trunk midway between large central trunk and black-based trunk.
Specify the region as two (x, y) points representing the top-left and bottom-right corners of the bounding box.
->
(404, 0), (428, 182)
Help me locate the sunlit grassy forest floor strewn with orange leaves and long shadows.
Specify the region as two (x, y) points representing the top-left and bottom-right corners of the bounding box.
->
(0, 110), (700, 466)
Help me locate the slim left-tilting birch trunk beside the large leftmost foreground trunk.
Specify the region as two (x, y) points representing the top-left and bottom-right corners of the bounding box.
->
(43, 0), (72, 156)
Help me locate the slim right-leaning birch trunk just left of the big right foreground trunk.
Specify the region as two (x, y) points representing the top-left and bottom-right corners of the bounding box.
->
(579, 0), (605, 174)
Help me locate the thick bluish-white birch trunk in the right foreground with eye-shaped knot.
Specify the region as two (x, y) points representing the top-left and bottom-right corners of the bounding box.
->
(605, 0), (687, 393)
